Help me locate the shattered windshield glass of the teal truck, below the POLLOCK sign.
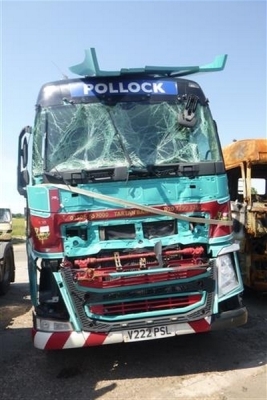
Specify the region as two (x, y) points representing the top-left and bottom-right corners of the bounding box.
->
(33, 101), (221, 174)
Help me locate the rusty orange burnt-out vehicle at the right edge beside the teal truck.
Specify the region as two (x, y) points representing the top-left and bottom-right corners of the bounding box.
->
(223, 139), (267, 292)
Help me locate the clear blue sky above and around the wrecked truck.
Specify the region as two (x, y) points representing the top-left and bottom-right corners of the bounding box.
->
(0, 0), (267, 213)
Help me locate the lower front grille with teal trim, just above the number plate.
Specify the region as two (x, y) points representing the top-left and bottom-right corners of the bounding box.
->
(61, 266), (215, 332)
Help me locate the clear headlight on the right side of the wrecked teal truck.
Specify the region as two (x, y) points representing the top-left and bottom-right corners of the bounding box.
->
(216, 254), (239, 297)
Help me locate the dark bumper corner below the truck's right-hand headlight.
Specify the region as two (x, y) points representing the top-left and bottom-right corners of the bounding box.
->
(211, 307), (248, 331)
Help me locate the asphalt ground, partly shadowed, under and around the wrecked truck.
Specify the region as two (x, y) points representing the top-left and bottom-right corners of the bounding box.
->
(0, 245), (267, 400)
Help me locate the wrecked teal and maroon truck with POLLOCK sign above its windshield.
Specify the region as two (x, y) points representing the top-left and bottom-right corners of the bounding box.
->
(18, 49), (247, 350)
